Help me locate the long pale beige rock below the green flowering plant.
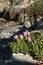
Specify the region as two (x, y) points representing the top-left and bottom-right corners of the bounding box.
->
(12, 53), (37, 64)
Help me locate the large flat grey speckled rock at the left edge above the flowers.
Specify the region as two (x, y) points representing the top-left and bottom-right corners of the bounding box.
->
(0, 25), (23, 39)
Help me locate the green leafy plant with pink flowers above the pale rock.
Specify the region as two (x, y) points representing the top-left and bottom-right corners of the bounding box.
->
(9, 32), (43, 61)
